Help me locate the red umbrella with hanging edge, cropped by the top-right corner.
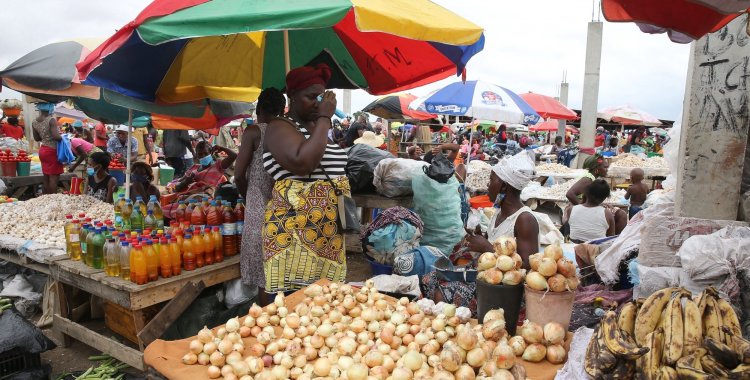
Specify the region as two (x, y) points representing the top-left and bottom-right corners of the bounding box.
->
(601, 0), (750, 43)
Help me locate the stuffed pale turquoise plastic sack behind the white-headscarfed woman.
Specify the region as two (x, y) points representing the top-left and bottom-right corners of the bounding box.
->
(411, 169), (465, 252)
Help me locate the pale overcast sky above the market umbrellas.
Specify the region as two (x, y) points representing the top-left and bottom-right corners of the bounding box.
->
(0, 0), (690, 120)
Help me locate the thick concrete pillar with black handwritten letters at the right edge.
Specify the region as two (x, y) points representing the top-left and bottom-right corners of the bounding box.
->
(675, 15), (750, 220)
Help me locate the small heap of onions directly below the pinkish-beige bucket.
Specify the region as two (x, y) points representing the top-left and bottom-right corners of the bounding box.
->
(509, 319), (567, 364)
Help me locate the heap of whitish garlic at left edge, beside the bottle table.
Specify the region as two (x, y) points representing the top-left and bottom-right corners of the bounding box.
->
(0, 194), (114, 249)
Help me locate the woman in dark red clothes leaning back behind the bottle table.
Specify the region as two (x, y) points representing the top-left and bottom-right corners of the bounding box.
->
(161, 140), (237, 219)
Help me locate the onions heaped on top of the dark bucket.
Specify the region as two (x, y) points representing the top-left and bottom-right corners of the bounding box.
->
(477, 236), (526, 285)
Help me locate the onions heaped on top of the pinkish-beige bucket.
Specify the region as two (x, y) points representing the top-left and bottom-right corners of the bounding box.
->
(526, 244), (580, 292)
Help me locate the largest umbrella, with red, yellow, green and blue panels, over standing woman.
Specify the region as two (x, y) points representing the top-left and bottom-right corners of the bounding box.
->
(78, 0), (484, 103)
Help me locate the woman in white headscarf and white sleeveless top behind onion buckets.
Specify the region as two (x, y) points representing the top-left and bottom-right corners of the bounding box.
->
(466, 152), (540, 269)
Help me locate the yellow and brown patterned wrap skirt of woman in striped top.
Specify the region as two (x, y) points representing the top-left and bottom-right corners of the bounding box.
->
(263, 176), (350, 292)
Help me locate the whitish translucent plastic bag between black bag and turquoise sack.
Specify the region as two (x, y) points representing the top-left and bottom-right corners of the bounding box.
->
(372, 158), (427, 198)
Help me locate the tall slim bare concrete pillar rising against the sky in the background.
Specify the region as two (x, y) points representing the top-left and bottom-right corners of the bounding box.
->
(578, 21), (604, 168)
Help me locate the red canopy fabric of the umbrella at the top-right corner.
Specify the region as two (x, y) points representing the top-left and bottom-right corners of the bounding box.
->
(602, 0), (741, 39)
